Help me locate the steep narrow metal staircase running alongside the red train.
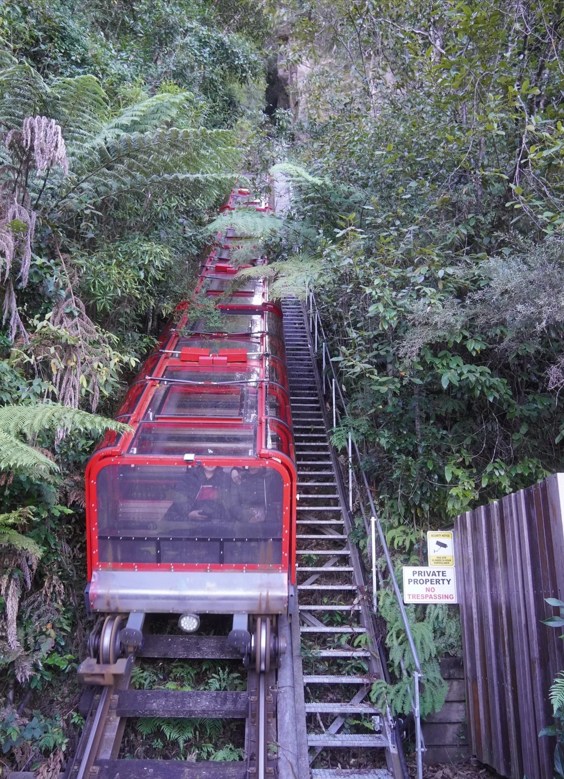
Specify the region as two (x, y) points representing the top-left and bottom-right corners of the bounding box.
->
(282, 299), (407, 779)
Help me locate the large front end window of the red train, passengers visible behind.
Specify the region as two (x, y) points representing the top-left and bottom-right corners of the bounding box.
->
(96, 465), (284, 566)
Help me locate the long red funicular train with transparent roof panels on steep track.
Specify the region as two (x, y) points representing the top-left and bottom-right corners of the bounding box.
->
(86, 190), (296, 663)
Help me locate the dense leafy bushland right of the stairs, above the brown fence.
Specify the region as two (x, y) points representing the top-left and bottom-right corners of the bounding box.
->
(262, 0), (564, 711)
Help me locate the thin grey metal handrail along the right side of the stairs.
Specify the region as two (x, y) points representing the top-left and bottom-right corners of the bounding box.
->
(307, 291), (425, 779)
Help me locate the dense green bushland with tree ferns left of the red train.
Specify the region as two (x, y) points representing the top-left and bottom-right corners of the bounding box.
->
(0, 0), (267, 773)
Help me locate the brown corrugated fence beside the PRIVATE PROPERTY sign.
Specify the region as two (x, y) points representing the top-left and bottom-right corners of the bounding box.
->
(455, 474), (564, 779)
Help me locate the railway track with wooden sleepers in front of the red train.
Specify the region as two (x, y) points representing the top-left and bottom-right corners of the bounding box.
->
(63, 635), (277, 779)
